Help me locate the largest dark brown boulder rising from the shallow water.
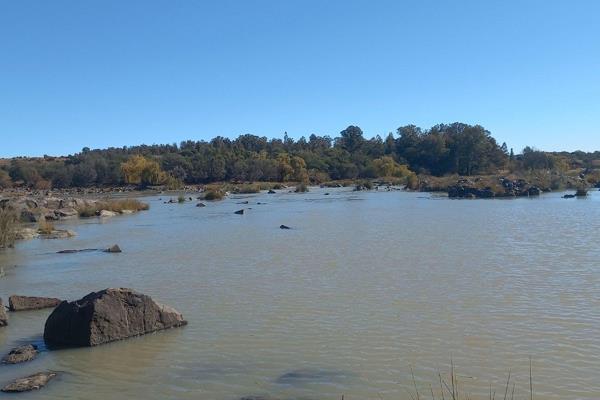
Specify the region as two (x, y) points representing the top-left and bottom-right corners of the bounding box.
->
(44, 288), (187, 346)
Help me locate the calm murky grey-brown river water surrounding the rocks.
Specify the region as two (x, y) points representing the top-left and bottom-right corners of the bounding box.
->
(0, 188), (600, 400)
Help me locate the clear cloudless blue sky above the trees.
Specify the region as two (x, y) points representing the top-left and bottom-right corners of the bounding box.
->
(0, 0), (600, 156)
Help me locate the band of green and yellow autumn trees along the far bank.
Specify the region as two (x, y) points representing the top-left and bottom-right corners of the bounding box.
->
(0, 123), (600, 189)
